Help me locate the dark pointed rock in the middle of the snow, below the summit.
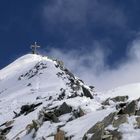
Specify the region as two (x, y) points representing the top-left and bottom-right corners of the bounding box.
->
(54, 102), (72, 117)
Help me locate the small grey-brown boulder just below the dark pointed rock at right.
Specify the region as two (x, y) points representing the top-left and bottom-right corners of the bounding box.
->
(113, 114), (128, 127)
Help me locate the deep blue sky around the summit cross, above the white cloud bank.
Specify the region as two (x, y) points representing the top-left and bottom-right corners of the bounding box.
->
(0, 0), (140, 89)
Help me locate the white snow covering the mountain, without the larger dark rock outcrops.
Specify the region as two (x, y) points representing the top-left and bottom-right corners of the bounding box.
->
(0, 54), (140, 140)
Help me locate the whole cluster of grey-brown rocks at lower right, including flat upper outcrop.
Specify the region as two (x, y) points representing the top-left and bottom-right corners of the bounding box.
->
(83, 96), (140, 140)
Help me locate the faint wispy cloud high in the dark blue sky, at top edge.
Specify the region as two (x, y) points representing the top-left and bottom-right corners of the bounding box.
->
(43, 0), (126, 28)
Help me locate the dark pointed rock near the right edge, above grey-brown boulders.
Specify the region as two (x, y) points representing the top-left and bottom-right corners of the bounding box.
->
(119, 100), (138, 115)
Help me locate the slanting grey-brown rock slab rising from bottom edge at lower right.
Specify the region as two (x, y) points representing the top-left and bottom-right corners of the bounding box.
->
(83, 112), (123, 140)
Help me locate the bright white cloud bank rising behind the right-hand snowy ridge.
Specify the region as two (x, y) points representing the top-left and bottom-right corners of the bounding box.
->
(42, 39), (140, 90)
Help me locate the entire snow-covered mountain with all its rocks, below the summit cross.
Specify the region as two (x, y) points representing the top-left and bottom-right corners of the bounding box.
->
(0, 54), (140, 140)
